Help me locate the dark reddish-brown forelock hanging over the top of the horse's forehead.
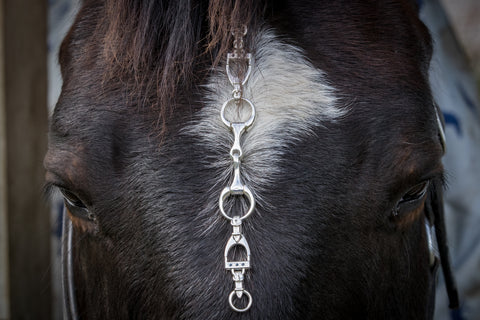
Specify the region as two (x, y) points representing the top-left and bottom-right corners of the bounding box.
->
(102, 0), (264, 130)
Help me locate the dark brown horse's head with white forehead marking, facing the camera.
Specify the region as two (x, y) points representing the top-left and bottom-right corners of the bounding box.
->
(45, 0), (457, 319)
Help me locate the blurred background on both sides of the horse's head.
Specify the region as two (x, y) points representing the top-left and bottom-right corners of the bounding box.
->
(0, 0), (480, 320)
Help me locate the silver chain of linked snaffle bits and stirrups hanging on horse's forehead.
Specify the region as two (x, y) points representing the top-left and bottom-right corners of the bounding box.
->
(219, 26), (256, 312)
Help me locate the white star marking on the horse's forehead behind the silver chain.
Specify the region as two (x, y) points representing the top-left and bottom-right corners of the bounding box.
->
(186, 31), (346, 218)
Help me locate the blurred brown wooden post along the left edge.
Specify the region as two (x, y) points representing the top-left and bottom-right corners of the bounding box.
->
(0, 0), (51, 319)
